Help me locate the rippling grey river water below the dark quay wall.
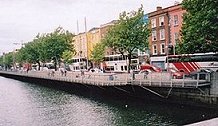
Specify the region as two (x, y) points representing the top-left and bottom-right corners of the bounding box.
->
(0, 77), (218, 126)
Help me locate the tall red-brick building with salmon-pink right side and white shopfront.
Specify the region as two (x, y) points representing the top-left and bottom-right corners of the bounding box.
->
(148, 3), (185, 69)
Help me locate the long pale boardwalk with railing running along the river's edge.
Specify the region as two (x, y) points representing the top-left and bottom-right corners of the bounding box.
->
(0, 71), (210, 88)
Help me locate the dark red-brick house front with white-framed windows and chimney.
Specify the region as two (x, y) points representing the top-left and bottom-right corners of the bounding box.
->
(148, 7), (170, 56)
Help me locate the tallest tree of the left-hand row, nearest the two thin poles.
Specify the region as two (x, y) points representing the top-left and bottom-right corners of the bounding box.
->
(40, 27), (75, 70)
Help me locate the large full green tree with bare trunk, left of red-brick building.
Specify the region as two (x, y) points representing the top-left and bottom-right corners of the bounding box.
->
(103, 7), (150, 72)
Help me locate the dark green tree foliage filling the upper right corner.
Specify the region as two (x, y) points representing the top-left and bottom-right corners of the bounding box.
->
(177, 0), (218, 53)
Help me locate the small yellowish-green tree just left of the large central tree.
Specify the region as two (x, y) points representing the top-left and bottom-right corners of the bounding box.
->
(91, 42), (105, 64)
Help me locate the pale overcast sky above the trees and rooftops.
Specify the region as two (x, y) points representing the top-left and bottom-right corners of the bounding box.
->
(0, 0), (182, 55)
